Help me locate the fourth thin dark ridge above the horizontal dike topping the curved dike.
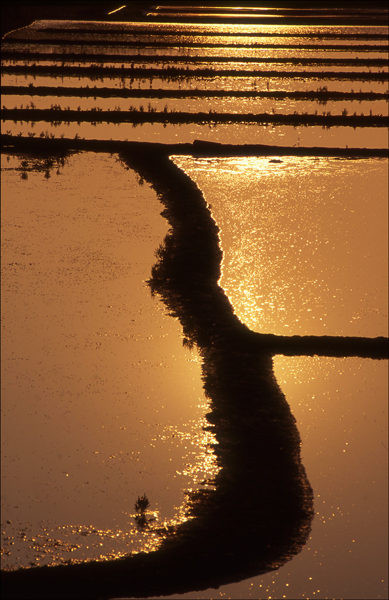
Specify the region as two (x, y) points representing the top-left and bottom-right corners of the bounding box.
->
(1, 50), (388, 67)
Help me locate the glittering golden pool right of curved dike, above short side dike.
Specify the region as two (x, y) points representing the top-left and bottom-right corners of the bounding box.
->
(174, 157), (388, 336)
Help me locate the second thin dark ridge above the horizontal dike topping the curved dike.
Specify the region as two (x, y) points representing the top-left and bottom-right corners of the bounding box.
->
(1, 84), (389, 104)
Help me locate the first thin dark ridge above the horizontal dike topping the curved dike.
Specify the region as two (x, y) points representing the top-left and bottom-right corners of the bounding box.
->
(2, 108), (389, 127)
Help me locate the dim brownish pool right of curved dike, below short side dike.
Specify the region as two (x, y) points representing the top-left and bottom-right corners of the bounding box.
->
(159, 356), (388, 600)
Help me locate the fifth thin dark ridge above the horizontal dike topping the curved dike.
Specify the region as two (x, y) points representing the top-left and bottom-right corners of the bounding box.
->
(4, 37), (389, 52)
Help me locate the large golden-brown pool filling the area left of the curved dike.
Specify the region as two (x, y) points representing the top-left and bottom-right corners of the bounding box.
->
(1, 153), (218, 568)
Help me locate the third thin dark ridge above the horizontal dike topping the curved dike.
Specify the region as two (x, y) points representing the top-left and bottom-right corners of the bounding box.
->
(1, 59), (389, 81)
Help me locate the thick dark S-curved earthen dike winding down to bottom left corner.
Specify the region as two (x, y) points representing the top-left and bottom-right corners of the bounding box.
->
(3, 145), (313, 600)
